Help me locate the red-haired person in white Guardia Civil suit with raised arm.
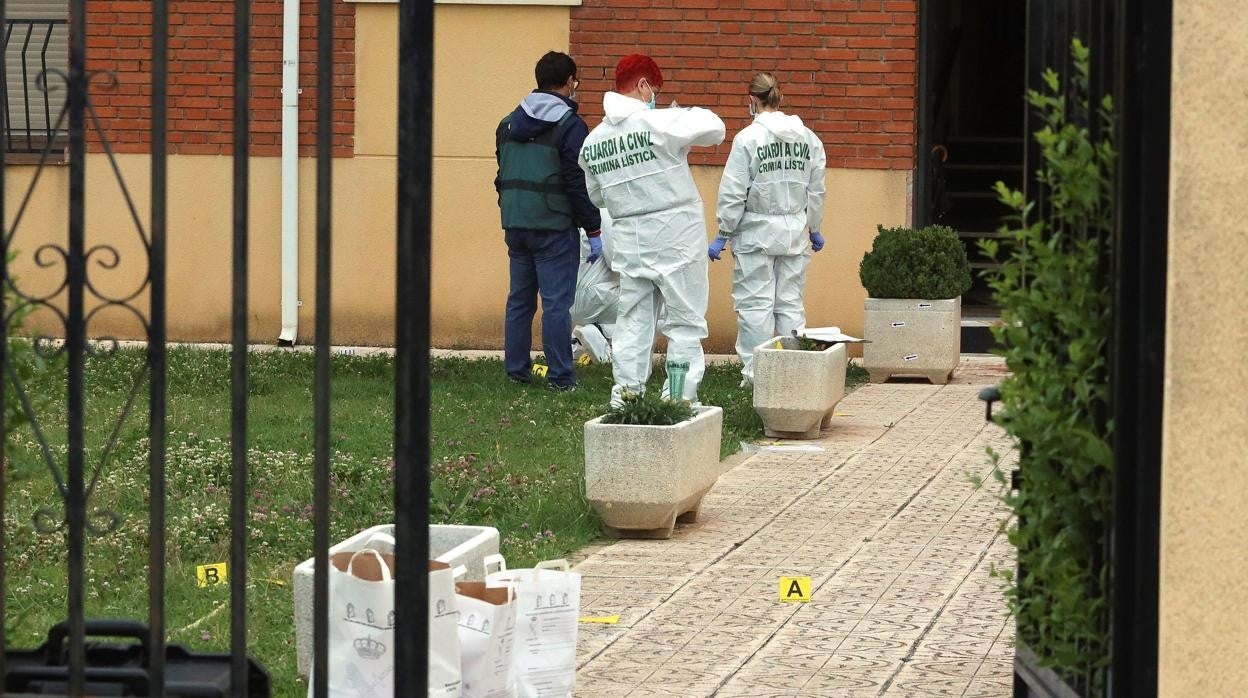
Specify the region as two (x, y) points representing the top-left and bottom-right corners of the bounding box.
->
(580, 54), (724, 405)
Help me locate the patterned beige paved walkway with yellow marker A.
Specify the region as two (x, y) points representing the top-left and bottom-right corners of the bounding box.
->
(577, 358), (1013, 698)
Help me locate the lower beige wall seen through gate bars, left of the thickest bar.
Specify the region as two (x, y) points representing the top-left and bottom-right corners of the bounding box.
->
(5, 155), (394, 343)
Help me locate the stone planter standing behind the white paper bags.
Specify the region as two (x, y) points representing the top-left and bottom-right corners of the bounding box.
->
(291, 523), (498, 677)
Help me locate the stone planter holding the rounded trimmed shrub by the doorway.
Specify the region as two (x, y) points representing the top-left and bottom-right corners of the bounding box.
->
(862, 297), (962, 385)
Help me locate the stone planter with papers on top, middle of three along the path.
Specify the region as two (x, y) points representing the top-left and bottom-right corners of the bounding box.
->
(754, 337), (849, 438)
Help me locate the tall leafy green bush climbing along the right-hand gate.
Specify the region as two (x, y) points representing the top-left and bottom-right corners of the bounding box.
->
(981, 41), (1113, 696)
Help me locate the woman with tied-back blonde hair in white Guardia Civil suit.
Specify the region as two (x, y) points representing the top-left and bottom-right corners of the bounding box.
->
(708, 72), (826, 387)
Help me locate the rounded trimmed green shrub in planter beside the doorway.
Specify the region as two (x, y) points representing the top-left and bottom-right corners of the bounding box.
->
(859, 226), (971, 300)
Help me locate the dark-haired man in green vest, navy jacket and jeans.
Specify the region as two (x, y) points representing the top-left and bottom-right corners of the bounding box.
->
(494, 51), (602, 390)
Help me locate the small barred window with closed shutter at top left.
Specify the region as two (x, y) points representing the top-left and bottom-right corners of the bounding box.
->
(0, 19), (69, 154)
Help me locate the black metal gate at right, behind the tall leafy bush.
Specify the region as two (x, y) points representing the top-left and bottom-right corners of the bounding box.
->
(1016, 0), (1172, 698)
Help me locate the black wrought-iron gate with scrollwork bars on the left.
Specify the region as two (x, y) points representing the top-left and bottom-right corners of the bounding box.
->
(0, 0), (433, 697)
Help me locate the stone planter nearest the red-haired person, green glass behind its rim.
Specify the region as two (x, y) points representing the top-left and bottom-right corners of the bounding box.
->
(585, 407), (724, 538)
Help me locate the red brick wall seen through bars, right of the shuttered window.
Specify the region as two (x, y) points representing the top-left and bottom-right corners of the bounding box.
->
(86, 0), (356, 157)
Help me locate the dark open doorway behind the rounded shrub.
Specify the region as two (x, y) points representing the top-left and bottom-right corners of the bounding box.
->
(915, 0), (1027, 322)
